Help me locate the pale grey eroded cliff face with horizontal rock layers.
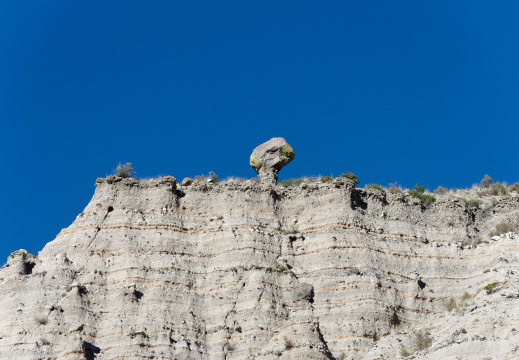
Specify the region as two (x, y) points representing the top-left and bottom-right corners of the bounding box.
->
(0, 177), (519, 360)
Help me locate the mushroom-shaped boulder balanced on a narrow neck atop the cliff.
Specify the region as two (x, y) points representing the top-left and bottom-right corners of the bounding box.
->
(250, 138), (295, 184)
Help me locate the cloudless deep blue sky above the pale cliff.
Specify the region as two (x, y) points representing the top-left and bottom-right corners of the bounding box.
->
(0, 0), (519, 263)
